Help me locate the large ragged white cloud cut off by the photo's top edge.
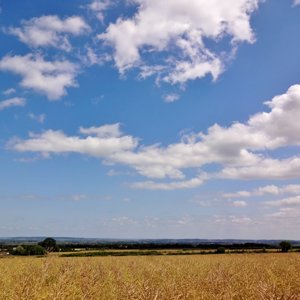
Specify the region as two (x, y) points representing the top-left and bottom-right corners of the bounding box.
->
(99, 0), (260, 84)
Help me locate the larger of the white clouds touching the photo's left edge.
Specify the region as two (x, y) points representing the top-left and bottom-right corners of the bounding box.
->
(0, 54), (77, 100)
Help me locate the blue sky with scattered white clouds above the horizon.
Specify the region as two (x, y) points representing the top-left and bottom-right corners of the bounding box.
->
(0, 0), (300, 239)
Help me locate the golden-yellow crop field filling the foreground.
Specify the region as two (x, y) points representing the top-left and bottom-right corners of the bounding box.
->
(0, 253), (300, 300)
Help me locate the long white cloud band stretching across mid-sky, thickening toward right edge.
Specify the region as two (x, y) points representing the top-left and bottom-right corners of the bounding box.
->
(7, 85), (300, 189)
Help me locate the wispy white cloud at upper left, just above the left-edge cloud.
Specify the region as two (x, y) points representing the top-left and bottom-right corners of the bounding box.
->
(6, 15), (90, 51)
